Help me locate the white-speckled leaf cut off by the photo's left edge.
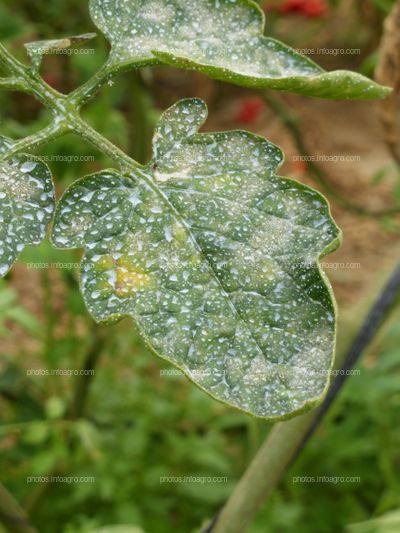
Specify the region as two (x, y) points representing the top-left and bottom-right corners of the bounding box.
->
(0, 143), (55, 276)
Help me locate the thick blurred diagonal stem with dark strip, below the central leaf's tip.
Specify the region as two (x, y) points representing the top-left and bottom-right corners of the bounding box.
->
(211, 265), (400, 533)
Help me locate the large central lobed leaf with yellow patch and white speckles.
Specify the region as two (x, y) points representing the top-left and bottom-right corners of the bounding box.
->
(52, 99), (340, 419)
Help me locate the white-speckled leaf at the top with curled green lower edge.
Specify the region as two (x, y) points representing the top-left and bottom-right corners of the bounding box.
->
(90, 0), (391, 99)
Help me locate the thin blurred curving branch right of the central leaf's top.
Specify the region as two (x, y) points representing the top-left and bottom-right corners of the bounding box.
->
(261, 92), (400, 218)
